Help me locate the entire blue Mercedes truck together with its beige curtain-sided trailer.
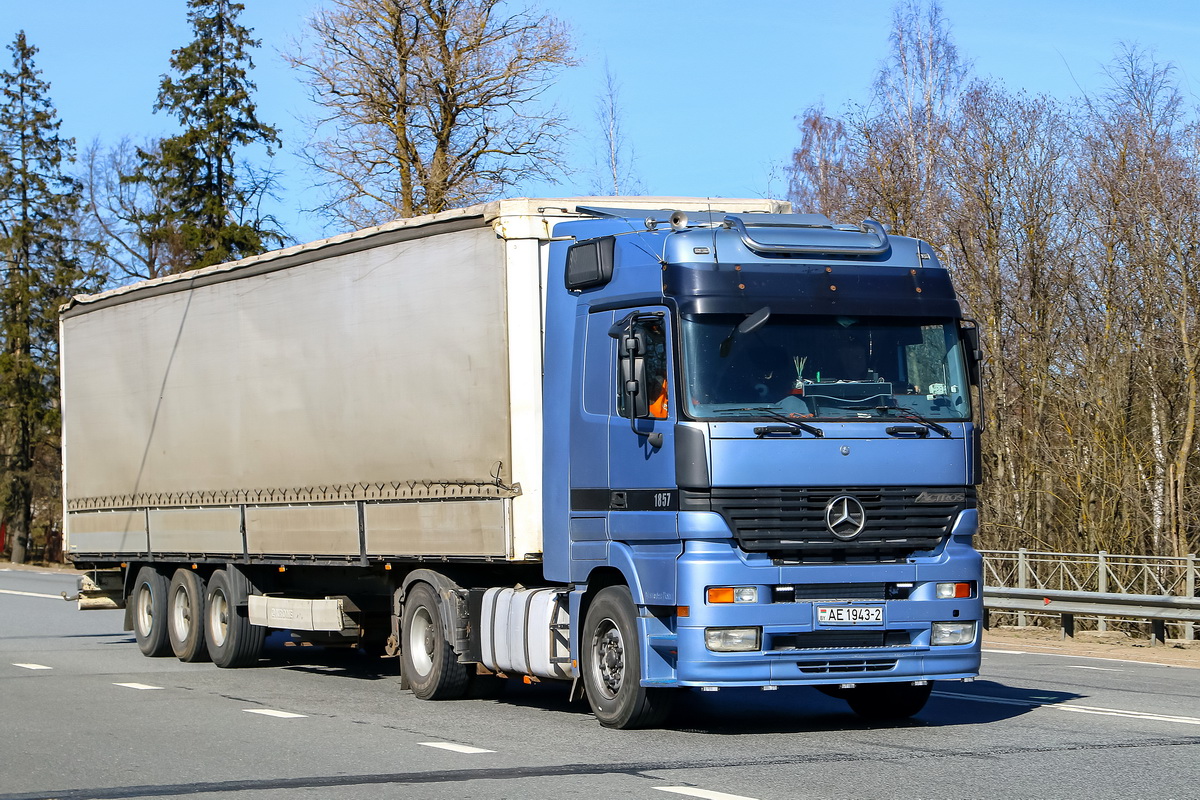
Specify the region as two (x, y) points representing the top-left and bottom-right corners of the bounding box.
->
(61, 198), (983, 728)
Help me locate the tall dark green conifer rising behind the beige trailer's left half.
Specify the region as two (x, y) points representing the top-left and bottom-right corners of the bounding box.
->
(135, 0), (283, 272)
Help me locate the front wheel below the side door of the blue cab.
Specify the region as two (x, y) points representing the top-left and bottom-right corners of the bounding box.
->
(580, 587), (674, 729)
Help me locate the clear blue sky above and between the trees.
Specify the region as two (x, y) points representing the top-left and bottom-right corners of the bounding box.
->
(0, 0), (1200, 241)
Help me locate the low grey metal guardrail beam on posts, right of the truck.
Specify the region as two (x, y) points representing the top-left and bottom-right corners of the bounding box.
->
(983, 585), (1200, 644)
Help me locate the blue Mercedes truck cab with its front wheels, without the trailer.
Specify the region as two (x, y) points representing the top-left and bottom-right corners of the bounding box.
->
(544, 207), (983, 727)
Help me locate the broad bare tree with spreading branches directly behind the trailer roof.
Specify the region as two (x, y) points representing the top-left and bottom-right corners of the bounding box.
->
(288, 0), (572, 227)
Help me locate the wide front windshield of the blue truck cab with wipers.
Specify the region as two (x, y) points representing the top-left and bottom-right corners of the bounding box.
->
(680, 314), (971, 420)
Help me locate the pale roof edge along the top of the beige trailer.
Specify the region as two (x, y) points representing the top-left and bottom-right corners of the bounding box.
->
(61, 197), (791, 317)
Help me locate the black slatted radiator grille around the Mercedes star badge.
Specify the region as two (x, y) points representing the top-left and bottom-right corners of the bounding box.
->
(680, 487), (976, 560)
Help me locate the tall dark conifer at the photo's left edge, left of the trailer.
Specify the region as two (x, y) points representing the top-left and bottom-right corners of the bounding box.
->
(0, 31), (90, 563)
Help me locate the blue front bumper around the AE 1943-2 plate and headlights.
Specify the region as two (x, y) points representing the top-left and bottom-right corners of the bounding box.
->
(662, 515), (983, 687)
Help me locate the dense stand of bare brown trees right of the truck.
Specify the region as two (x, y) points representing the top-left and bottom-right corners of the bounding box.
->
(791, 0), (1200, 568)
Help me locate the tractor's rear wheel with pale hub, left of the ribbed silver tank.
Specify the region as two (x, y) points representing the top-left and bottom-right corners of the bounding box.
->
(401, 583), (470, 700)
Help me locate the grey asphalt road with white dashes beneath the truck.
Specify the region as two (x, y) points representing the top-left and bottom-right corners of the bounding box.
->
(0, 571), (1200, 800)
